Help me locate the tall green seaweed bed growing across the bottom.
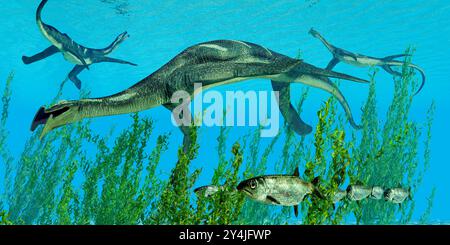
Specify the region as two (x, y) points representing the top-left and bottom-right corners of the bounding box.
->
(0, 50), (436, 224)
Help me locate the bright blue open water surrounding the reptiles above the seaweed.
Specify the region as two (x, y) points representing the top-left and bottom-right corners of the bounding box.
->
(0, 0), (450, 222)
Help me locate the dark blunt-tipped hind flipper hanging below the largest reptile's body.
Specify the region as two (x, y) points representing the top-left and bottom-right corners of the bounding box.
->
(272, 80), (312, 135)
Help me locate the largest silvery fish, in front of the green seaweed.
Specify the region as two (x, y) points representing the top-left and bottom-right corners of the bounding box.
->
(237, 167), (323, 217)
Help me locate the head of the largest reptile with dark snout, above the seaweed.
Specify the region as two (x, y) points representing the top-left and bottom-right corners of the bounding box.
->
(31, 101), (81, 139)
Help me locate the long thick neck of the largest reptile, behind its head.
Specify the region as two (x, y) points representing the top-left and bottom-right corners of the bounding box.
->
(78, 75), (170, 118)
